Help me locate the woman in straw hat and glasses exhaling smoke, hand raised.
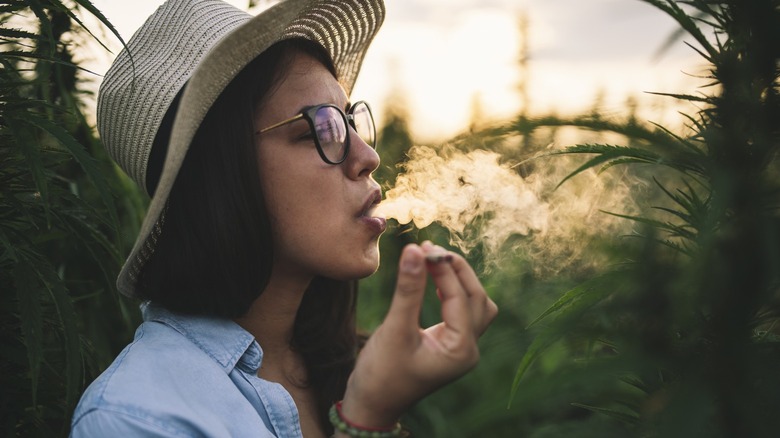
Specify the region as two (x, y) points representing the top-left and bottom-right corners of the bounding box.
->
(72, 0), (496, 437)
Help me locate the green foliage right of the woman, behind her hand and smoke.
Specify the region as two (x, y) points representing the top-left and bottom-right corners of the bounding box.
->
(361, 0), (780, 437)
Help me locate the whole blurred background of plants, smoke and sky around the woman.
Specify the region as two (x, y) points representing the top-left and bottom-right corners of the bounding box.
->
(0, 0), (780, 438)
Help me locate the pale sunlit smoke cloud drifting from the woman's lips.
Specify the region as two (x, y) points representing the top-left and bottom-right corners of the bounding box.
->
(378, 146), (635, 273)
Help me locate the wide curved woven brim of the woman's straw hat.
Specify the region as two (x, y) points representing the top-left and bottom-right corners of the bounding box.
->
(117, 0), (384, 297)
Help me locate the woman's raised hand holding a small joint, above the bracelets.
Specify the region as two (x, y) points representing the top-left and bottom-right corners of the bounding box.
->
(342, 242), (498, 427)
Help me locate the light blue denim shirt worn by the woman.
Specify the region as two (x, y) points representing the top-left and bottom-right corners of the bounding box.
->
(71, 305), (301, 438)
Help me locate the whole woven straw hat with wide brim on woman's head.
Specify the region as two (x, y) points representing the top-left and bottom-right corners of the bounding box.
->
(97, 0), (385, 296)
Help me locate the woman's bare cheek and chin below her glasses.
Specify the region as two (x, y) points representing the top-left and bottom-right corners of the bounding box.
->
(260, 149), (379, 279)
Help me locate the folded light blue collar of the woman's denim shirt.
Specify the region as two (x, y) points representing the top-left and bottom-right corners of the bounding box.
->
(141, 302), (263, 374)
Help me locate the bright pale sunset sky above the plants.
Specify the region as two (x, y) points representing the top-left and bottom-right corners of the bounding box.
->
(84, 0), (703, 142)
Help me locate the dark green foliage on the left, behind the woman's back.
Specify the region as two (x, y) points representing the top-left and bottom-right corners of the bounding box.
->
(0, 0), (142, 436)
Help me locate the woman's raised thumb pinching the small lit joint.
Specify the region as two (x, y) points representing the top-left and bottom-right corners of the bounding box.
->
(384, 244), (427, 330)
